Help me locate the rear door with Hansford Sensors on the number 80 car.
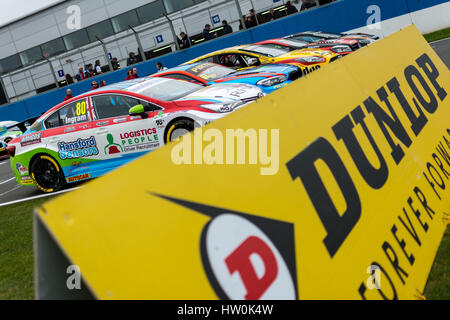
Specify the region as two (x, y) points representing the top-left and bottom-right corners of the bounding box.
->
(41, 98), (101, 182)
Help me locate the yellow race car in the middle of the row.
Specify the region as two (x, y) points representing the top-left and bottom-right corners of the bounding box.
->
(184, 44), (340, 75)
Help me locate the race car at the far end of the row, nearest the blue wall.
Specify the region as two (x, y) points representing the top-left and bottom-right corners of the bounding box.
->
(284, 31), (379, 47)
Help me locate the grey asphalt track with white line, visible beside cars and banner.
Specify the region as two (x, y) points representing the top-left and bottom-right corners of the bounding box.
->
(0, 38), (450, 207)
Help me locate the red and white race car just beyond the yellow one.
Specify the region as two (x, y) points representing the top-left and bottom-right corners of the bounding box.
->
(256, 38), (360, 56)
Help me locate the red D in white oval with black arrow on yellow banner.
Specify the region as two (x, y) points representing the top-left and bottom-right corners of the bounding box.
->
(151, 193), (298, 300)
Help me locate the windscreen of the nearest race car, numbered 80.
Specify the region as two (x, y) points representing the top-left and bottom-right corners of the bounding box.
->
(138, 78), (203, 101)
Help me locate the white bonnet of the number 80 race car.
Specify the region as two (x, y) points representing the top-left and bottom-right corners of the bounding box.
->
(175, 83), (264, 103)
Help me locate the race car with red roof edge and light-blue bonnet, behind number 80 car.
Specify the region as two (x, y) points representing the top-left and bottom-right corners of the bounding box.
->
(151, 62), (302, 94)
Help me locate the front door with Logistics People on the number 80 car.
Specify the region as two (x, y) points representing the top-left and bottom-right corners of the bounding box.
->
(92, 94), (164, 167)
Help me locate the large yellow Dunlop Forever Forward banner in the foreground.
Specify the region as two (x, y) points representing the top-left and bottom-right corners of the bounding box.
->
(37, 26), (450, 299)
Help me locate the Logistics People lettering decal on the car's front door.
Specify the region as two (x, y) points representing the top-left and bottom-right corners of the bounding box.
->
(119, 128), (160, 152)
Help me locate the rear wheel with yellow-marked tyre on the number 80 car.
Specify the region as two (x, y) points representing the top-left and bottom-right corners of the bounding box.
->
(31, 154), (65, 193)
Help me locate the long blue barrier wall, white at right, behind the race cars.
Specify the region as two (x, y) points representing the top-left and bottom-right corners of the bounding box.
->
(0, 0), (450, 121)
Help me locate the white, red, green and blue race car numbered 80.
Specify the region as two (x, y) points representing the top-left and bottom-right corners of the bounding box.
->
(7, 77), (264, 193)
